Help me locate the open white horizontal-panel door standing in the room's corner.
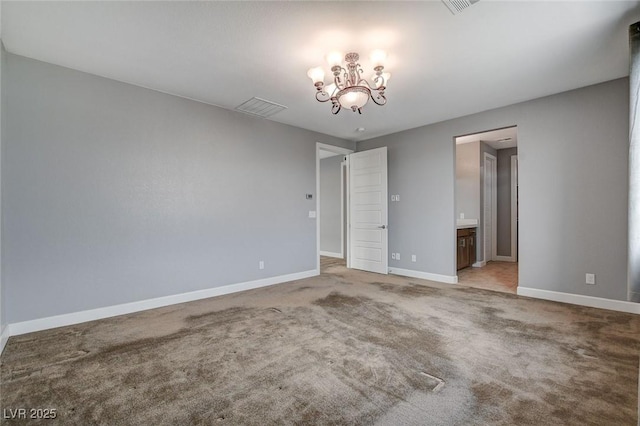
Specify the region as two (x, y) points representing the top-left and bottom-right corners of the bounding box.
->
(349, 147), (388, 274)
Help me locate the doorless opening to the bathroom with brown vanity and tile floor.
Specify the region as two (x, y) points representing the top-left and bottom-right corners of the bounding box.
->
(455, 126), (519, 294)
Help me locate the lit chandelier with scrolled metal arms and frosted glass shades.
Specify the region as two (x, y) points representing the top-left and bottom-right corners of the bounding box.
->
(307, 50), (391, 114)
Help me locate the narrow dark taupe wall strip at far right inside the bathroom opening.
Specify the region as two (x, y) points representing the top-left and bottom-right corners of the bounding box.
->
(497, 147), (518, 256)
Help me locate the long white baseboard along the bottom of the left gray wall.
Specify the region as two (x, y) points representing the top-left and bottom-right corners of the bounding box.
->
(7, 269), (319, 337)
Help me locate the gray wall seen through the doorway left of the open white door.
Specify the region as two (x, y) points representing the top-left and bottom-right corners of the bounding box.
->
(320, 155), (344, 253)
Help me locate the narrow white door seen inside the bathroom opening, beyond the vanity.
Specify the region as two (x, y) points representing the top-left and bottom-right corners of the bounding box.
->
(483, 152), (498, 262)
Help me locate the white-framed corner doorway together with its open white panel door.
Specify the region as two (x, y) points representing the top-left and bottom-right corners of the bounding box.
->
(316, 143), (389, 274)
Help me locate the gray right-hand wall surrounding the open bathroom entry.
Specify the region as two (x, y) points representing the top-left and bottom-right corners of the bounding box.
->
(358, 78), (629, 300)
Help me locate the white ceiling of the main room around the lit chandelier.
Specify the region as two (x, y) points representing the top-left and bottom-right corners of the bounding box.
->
(1, 0), (640, 140)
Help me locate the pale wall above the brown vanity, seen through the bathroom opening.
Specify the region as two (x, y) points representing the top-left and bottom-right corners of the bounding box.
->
(456, 142), (480, 220)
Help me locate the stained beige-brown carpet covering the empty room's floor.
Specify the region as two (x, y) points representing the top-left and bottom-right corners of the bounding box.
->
(0, 263), (640, 425)
